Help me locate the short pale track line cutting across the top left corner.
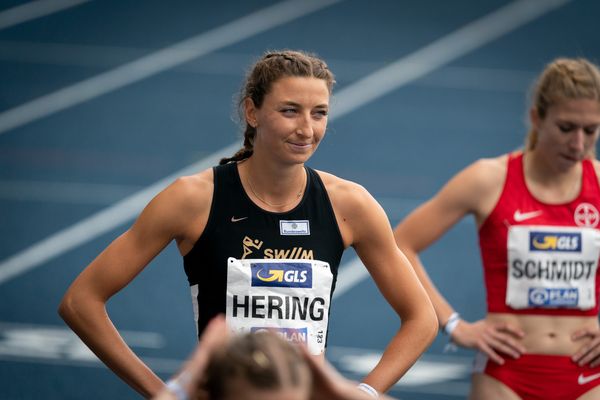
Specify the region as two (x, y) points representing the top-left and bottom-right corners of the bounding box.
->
(0, 0), (90, 29)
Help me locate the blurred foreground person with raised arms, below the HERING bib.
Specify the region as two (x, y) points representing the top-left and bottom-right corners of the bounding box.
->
(153, 316), (398, 400)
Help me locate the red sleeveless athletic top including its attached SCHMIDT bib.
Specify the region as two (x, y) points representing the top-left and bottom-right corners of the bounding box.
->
(479, 153), (600, 316)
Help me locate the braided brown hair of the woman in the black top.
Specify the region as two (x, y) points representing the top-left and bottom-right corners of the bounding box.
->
(219, 50), (335, 165)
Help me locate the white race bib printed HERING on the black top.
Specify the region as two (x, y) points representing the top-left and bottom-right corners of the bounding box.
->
(226, 258), (333, 355)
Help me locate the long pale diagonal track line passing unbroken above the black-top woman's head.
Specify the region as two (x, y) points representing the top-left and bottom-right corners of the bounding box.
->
(0, 0), (341, 134)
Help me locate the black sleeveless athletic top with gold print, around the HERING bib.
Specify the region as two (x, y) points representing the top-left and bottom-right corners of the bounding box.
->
(183, 163), (344, 335)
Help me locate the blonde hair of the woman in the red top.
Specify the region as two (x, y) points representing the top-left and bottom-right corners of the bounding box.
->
(525, 58), (600, 157)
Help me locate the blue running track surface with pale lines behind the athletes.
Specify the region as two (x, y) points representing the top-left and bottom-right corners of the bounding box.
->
(0, 0), (600, 400)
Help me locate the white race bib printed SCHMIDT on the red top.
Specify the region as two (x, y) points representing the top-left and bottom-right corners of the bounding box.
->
(506, 225), (600, 310)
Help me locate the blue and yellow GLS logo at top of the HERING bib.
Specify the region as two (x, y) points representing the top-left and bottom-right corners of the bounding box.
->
(251, 263), (312, 288)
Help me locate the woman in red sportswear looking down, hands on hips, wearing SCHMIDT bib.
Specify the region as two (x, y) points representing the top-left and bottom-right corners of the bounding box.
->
(395, 59), (600, 400)
